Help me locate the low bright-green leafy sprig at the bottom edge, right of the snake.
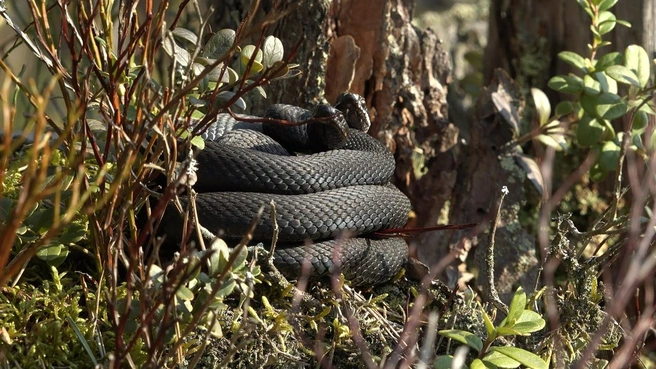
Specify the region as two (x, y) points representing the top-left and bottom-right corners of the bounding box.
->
(434, 287), (549, 369)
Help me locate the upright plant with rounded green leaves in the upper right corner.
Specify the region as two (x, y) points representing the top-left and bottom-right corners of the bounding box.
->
(533, 0), (656, 180)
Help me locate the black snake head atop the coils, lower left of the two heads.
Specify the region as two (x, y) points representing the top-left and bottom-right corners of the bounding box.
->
(307, 104), (349, 150)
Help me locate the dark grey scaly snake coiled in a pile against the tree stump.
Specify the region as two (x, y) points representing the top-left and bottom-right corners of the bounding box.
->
(164, 93), (410, 286)
